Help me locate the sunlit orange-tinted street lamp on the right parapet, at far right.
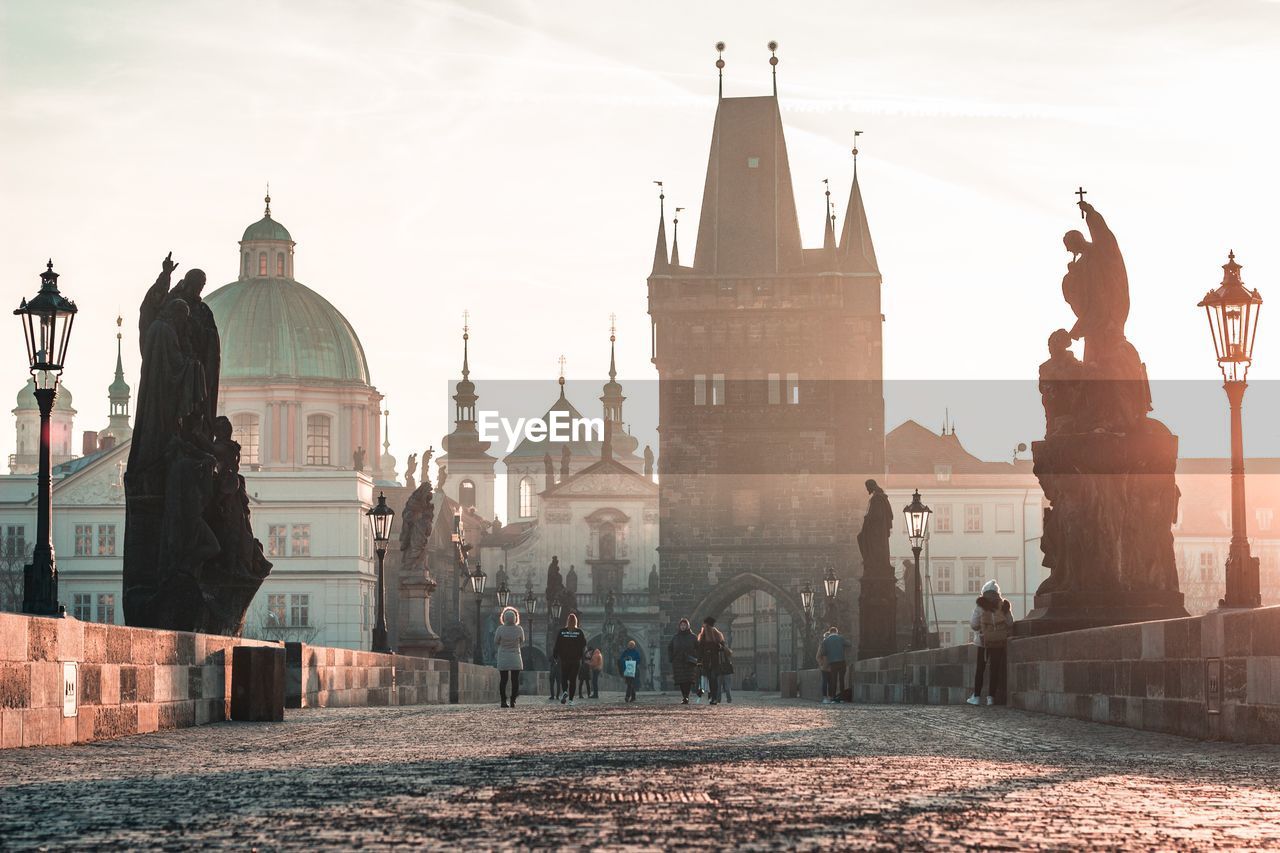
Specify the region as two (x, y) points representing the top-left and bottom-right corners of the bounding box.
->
(1199, 252), (1262, 607)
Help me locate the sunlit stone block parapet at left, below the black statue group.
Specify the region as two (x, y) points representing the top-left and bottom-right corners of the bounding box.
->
(0, 613), (271, 748)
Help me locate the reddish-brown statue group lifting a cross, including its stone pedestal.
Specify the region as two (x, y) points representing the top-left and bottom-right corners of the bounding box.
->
(1019, 195), (1185, 633)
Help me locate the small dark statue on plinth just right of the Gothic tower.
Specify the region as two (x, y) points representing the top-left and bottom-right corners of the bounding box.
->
(858, 480), (899, 658)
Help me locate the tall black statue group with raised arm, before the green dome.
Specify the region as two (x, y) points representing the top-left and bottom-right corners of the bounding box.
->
(123, 252), (271, 635)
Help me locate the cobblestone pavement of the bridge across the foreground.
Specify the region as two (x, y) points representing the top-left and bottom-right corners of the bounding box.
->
(0, 694), (1280, 850)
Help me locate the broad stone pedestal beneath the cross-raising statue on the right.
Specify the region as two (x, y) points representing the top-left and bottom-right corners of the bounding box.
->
(1018, 419), (1187, 634)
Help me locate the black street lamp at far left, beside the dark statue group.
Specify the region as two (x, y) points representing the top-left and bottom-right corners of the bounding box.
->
(14, 260), (76, 616)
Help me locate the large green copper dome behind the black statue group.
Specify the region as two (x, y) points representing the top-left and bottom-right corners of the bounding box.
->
(205, 275), (370, 386)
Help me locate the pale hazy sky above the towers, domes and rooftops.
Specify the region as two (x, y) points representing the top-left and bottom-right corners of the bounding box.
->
(0, 0), (1280, 464)
